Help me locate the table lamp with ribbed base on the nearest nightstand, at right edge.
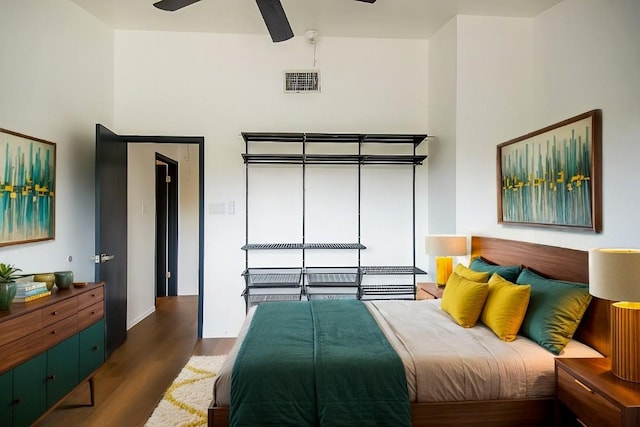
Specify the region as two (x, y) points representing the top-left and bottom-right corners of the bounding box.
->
(589, 249), (640, 382)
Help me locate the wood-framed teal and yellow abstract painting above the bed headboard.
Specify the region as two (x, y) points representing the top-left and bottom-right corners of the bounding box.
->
(497, 110), (602, 232)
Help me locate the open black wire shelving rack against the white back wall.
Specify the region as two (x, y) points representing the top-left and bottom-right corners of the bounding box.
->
(242, 132), (427, 303)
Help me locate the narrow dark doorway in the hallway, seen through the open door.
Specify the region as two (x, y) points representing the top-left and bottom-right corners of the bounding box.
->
(155, 152), (179, 298)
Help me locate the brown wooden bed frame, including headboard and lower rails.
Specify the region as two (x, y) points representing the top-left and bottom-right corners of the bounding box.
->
(208, 236), (610, 427)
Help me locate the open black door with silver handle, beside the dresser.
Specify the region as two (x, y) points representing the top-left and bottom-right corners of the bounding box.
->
(95, 124), (127, 357)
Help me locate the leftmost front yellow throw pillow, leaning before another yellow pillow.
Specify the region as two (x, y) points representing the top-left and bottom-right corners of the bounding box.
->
(440, 272), (489, 328)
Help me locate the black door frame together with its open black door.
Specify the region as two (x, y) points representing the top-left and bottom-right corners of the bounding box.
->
(95, 124), (204, 357)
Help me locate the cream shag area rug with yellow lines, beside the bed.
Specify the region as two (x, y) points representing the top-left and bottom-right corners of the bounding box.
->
(145, 356), (227, 427)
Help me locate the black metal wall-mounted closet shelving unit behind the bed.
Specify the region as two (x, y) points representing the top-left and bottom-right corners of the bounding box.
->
(242, 132), (427, 307)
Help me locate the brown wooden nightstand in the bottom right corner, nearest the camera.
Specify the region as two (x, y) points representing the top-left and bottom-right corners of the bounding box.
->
(556, 358), (640, 427)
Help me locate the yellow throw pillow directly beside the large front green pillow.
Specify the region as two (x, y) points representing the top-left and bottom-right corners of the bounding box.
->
(480, 273), (531, 341)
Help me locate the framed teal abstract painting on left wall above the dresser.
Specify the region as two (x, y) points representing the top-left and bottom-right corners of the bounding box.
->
(0, 128), (56, 246)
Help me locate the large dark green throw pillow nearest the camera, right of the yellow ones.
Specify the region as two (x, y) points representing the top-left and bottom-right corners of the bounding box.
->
(516, 268), (591, 355)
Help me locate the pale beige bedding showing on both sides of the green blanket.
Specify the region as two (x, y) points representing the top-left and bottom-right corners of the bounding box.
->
(214, 300), (602, 406)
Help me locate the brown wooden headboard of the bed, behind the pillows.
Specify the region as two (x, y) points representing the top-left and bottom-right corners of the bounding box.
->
(471, 236), (611, 356)
